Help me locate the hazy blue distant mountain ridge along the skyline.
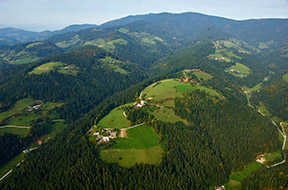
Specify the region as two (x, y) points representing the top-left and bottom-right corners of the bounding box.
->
(0, 13), (288, 45)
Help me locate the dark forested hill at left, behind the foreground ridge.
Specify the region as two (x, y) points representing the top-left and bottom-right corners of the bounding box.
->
(0, 47), (146, 122)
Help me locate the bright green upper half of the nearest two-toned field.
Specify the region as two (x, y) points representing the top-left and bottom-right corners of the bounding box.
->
(111, 125), (159, 149)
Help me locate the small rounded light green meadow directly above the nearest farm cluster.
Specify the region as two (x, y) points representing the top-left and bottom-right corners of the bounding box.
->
(97, 108), (130, 129)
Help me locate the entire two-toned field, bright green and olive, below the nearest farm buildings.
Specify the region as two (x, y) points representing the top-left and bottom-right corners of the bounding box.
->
(100, 125), (163, 167)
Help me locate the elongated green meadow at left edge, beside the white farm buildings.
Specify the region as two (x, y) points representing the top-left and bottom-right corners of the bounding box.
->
(0, 98), (34, 121)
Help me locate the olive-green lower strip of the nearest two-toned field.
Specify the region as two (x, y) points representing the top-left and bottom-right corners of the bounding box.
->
(100, 145), (164, 168)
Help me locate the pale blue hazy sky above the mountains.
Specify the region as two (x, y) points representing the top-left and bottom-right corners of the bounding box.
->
(0, 0), (288, 31)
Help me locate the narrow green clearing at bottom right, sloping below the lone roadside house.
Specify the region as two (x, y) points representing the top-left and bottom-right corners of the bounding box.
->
(226, 161), (261, 189)
